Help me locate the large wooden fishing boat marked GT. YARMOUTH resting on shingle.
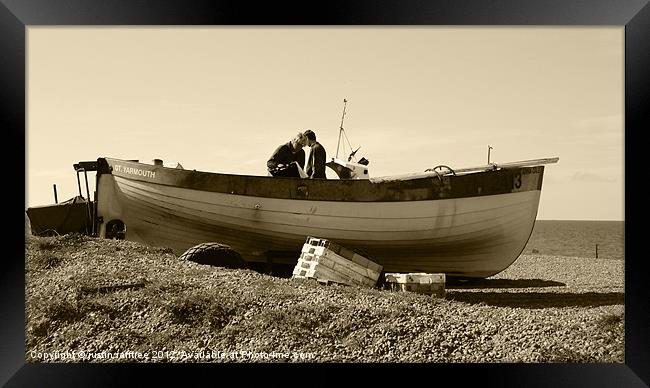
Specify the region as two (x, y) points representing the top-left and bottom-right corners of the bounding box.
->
(66, 157), (558, 278)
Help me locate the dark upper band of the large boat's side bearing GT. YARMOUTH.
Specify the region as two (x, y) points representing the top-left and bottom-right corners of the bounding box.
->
(98, 158), (544, 202)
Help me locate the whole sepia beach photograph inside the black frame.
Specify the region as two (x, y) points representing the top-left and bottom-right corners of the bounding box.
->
(24, 26), (625, 364)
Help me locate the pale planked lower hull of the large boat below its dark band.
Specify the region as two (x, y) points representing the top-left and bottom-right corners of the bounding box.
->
(98, 165), (541, 277)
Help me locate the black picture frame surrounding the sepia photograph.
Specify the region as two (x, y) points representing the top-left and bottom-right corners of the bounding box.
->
(0, 0), (650, 387)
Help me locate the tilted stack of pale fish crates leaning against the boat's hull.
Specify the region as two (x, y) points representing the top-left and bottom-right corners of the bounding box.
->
(293, 236), (383, 287)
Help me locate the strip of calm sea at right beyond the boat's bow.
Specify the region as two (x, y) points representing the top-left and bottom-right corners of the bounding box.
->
(522, 220), (625, 260)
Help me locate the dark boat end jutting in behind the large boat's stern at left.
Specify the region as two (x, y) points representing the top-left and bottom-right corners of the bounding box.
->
(27, 197), (92, 236)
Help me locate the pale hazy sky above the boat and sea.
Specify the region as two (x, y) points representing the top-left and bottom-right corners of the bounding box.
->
(26, 26), (624, 220)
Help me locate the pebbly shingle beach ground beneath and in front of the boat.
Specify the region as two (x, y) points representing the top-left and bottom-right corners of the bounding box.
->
(26, 235), (624, 363)
